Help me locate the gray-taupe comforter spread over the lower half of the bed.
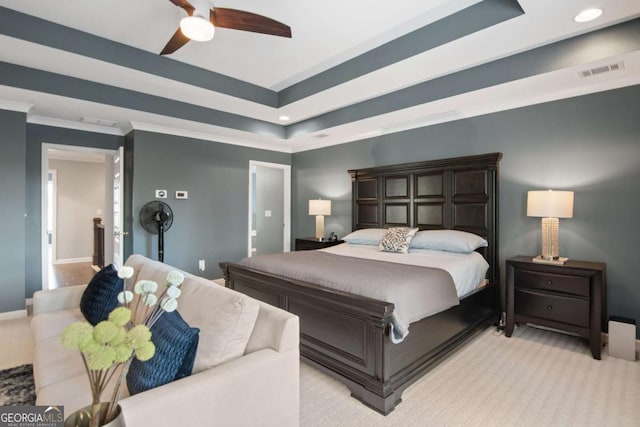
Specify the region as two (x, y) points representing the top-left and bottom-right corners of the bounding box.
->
(240, 251), (460, 343)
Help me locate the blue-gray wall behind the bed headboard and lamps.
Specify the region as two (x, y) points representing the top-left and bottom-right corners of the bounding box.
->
(292, 86), (640, 336)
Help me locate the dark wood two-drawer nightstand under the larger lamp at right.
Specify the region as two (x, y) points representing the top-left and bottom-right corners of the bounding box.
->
(505, 256), (607, 360)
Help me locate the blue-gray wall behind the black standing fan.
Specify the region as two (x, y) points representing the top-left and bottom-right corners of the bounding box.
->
(127, 131), (291, 278)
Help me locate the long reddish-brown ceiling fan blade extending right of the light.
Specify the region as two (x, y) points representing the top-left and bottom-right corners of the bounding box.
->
(209, 8), (291, 38)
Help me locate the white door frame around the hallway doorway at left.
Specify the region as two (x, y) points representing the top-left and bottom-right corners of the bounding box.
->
(40, 142), (117, 290)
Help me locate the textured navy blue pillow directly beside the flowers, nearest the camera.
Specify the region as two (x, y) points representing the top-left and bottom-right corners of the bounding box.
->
(127, 311), (200, 396)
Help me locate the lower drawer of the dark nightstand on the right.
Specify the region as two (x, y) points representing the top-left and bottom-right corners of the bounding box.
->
(515, 289), (589, 328)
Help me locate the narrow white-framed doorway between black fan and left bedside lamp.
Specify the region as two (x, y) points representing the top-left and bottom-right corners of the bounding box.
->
(248, 160), (291, 256)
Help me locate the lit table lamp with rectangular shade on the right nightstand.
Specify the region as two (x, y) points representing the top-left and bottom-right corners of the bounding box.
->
(527, 190), (573, 264)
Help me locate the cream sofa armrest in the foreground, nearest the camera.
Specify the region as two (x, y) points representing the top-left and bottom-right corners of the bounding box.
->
(120, 348), (300, 427)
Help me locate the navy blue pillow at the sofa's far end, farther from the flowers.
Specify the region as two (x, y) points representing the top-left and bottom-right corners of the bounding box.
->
(80, 264), (122, 326)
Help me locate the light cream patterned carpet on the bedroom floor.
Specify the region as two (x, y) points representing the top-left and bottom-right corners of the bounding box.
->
(0, 318), (640, 427)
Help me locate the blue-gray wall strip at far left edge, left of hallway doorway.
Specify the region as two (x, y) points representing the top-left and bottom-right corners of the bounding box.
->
(0, 110), (27, 313)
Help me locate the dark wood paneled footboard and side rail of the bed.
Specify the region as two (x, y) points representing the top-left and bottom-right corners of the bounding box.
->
(220, 263), (497, 415)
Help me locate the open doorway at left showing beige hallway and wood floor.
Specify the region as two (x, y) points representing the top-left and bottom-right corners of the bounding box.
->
(41, 143), (114, 289)
